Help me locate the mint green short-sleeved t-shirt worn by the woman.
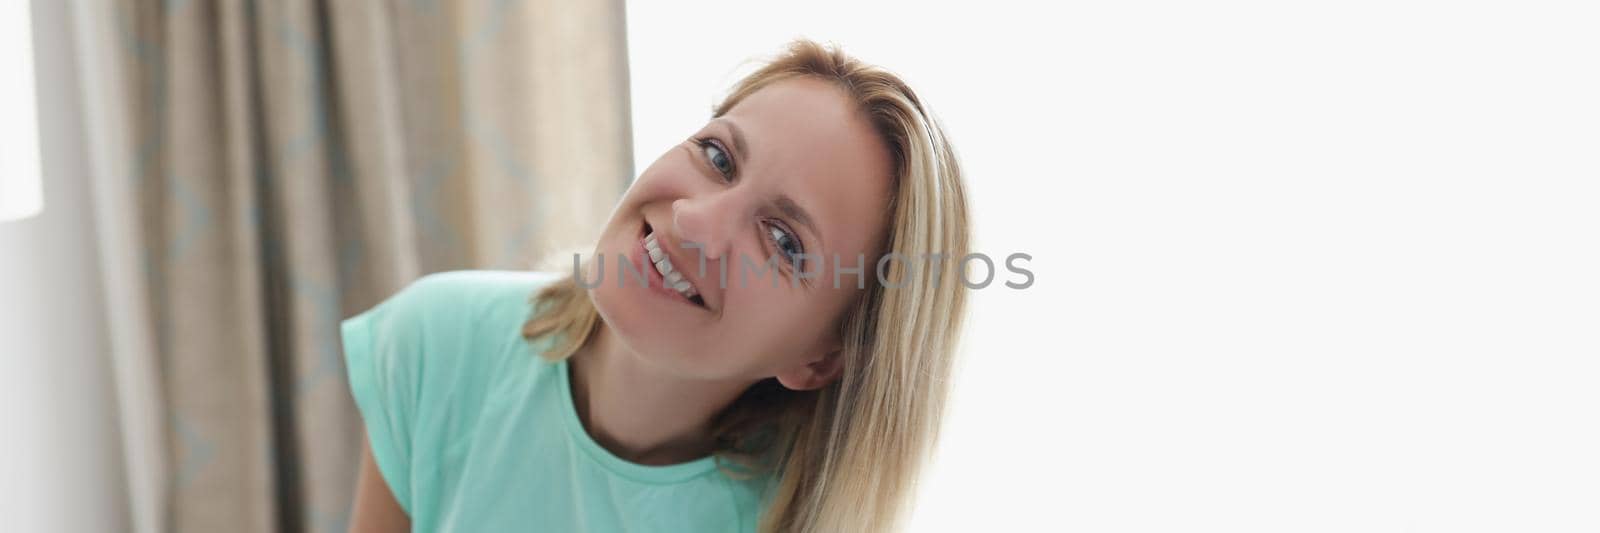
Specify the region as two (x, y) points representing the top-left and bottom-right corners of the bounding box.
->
(341, 271), (770, 533)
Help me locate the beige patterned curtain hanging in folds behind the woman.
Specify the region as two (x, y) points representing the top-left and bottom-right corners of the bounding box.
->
(74, 0), (632, 531)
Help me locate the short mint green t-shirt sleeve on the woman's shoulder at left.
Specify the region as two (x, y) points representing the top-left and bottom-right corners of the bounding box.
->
(339, 277), (434, 514)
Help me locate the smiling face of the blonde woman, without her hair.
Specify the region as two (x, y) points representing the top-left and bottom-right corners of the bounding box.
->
(586, 78), (891, 389)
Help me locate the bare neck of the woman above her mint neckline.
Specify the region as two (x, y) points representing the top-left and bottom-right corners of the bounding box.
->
(568, 322), (755, 466)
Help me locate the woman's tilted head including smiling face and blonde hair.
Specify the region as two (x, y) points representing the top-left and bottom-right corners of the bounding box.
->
(525, 40), (970, 531)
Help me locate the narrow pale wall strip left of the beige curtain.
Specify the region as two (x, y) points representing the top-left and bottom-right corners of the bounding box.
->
(0, 2), (128, 531)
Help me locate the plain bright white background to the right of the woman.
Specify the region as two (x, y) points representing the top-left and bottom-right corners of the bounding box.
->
(627, 2), (1600, 531)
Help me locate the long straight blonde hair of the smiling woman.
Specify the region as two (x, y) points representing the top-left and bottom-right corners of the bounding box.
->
(522, 40), (970, 531)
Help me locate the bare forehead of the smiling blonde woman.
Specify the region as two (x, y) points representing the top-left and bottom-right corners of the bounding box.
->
(725, 78), (893, 256)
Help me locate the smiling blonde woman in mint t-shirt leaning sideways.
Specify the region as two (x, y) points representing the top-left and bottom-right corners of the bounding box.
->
(342, 40), (968, 531)
